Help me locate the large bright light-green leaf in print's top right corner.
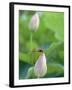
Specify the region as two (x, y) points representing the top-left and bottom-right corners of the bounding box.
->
(43, 12), (64, 41)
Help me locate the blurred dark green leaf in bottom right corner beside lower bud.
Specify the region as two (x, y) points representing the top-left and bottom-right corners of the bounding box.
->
(45, 63), (64, 77)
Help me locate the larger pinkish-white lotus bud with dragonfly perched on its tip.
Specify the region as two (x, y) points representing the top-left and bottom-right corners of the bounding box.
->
(34, 53), (47, 78)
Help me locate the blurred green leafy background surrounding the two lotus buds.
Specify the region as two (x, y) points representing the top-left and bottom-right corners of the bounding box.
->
(19, 10), (64, 79)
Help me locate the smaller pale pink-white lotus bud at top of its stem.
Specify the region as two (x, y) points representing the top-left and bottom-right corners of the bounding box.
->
(29, 13), (39, 31)
